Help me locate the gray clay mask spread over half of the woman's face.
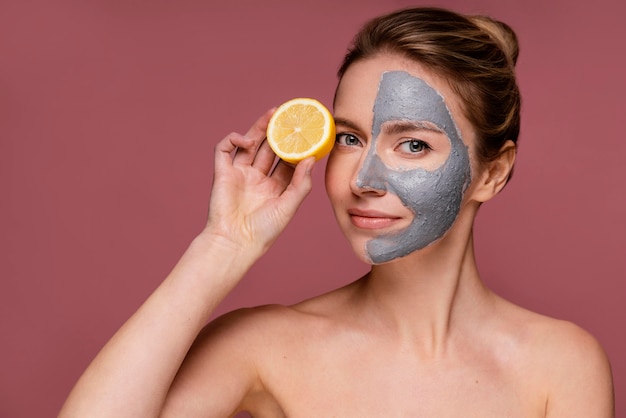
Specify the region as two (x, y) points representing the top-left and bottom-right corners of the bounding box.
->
(357, 71), (471, 264)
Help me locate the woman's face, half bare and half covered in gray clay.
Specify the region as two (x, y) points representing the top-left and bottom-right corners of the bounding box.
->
(326, 55), (474, 264)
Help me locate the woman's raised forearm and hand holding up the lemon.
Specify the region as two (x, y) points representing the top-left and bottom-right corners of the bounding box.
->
(59, 111), (313, 418)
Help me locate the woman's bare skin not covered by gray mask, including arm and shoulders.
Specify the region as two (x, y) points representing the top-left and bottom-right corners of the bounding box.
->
(60, 55), (614, 418)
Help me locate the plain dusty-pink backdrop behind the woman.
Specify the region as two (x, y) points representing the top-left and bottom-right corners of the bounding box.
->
(0, 0), (626, 418)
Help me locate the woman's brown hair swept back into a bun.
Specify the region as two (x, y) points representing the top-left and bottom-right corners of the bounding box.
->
(338, 8), (521, 168)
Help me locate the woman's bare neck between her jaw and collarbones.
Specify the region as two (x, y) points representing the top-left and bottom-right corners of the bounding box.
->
(360, 225), (491, 357)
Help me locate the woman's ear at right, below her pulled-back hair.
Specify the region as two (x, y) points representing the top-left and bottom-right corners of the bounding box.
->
(474, 140), (517, 202)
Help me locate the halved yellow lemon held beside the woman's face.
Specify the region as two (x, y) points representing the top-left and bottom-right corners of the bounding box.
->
(267, 98), (335, 164)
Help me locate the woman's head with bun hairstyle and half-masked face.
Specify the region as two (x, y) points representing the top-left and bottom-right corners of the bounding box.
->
(326, 9), (519, 263)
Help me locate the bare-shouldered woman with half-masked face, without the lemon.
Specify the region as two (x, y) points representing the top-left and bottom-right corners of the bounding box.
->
(61, 9), (613, 418)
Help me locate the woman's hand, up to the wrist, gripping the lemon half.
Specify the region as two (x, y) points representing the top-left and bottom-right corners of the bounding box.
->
(204, 109), (314, 252)
